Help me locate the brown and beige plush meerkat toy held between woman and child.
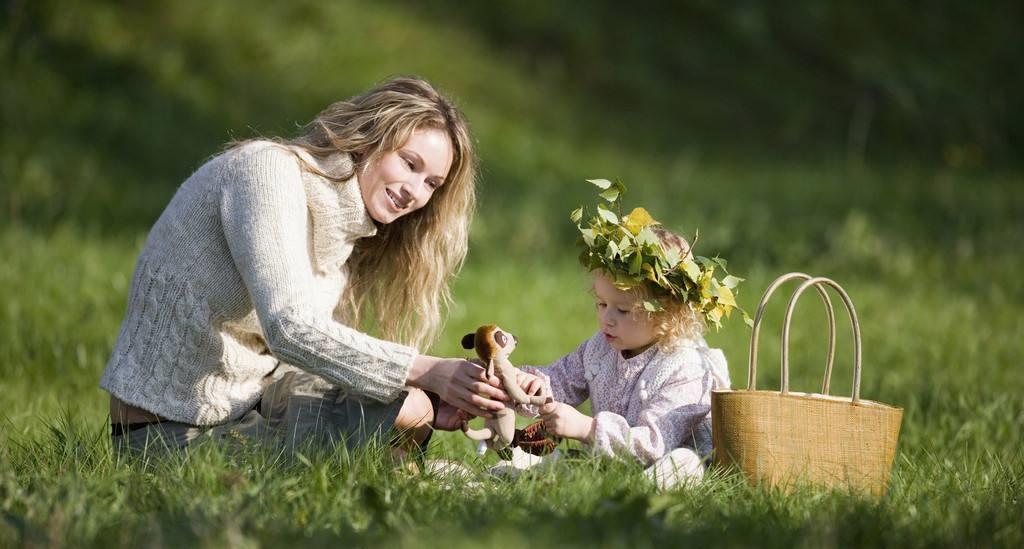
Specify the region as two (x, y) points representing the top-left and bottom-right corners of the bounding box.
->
(462, 324), (551, 454)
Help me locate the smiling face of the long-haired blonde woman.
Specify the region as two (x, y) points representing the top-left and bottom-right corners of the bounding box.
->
(359, 128), (453, 224)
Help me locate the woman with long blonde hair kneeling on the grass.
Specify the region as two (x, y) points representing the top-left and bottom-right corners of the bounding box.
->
(100, 78), (507, 449)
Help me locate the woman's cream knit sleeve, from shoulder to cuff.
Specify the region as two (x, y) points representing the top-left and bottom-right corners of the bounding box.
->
(219, 145), (417, 403)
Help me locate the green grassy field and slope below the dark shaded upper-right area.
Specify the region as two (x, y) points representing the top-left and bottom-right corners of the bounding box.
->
(0, 2), (1024, 547)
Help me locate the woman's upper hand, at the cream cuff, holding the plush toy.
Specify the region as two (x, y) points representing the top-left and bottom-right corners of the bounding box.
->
(406, 354), (508, 417)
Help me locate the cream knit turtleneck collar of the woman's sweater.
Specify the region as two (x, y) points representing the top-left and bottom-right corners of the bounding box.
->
(299, 146), (377, 271)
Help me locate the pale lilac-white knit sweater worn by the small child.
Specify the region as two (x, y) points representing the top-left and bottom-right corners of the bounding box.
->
(520, 332), (729, 465)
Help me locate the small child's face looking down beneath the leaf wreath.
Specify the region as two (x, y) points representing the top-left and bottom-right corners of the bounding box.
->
(594, 275), (657, 357)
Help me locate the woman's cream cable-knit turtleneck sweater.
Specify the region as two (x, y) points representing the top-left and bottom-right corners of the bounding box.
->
(99, 141), (417, 425)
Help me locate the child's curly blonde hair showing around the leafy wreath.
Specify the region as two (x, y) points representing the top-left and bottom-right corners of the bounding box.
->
(627, 227), (707, 352)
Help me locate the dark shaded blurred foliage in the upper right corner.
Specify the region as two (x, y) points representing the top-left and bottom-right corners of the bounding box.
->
(411, 0), (1024, 165)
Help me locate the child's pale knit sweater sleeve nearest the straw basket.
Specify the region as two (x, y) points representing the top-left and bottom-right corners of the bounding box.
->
(592, 354), (715, 466)
